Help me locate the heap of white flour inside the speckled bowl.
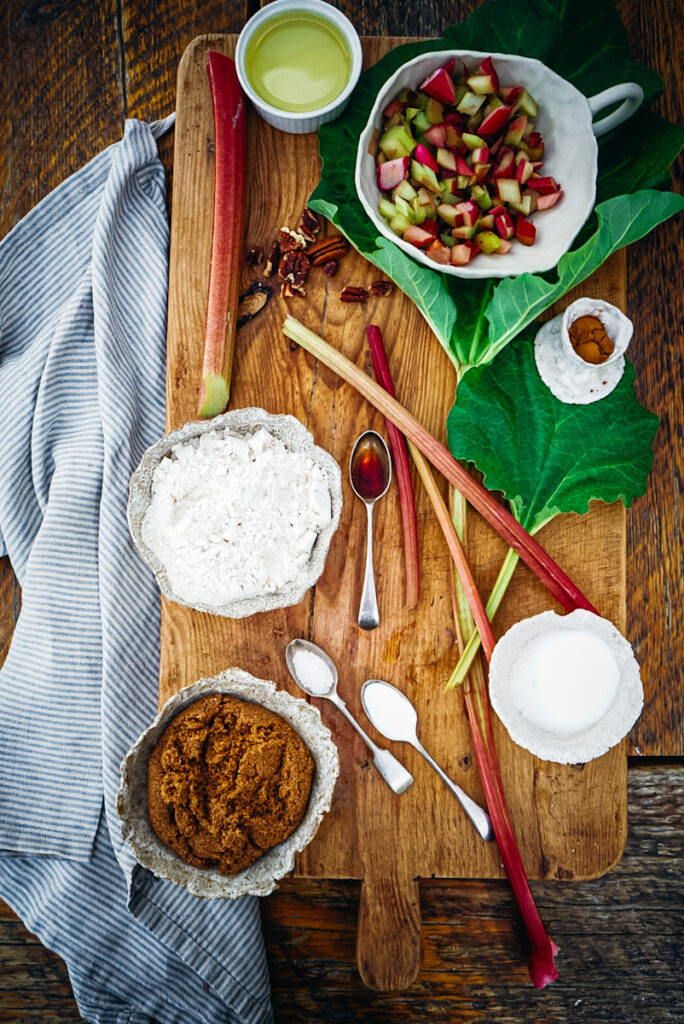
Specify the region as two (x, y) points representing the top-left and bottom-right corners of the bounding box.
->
(142, 427), (332, 605)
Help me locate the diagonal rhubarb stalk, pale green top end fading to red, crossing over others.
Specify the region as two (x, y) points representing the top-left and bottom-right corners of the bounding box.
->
(283, 316), (598, 614)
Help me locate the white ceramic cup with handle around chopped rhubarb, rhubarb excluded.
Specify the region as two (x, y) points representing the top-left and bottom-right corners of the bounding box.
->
(355, 50), (643, 279)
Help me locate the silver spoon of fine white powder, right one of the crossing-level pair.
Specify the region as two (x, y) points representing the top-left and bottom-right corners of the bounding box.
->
(361, 679), (494, 840)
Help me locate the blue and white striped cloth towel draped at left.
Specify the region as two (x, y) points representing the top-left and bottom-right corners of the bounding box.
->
(0, 121), (271, 1024)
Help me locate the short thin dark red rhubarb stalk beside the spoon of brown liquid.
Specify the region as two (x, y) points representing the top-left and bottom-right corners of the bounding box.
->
(366, 324), (420, 608)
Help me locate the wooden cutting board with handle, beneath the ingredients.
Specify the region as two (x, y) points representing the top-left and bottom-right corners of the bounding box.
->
(160, 36), (627, 989)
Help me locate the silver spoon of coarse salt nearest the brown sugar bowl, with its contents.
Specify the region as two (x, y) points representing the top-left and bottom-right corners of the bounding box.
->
(285, 639), (414, 794)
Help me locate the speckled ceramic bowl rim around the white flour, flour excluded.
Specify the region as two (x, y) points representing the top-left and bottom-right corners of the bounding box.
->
(128, 408), (342, 618)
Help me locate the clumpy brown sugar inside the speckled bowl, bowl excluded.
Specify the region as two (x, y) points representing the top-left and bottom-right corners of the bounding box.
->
(147, 693), (314, 874)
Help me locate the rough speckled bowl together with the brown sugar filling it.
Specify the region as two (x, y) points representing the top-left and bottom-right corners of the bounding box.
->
(117, 669), (339, 899)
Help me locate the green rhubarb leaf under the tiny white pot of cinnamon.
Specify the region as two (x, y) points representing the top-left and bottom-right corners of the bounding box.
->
(447, 338), (658, 531)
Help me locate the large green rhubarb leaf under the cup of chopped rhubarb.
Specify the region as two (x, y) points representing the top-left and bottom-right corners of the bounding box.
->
(309, 0), (684, 370)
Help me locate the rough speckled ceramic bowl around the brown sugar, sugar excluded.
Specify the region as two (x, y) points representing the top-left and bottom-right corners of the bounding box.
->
(117, 669), (340, 899)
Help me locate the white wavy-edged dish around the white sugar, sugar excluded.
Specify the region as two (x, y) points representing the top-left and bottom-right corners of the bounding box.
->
(489, 608), (644, 764)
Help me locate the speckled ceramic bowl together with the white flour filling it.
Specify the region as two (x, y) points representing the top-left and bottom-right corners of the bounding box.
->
(128, 409), (342, 618)
